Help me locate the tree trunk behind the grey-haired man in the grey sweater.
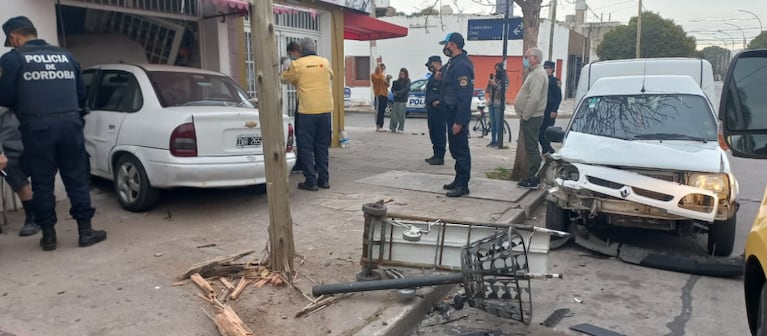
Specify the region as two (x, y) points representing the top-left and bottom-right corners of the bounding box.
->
(511, 0), (542, 181)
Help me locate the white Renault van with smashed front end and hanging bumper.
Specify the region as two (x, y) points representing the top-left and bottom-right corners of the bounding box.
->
(542, 59), (738, 256)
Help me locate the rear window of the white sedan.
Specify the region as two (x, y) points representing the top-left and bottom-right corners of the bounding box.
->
(148, 71), (253, 108)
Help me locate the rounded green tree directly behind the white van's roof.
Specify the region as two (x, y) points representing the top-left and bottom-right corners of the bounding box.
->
(597, 12), (695, 60)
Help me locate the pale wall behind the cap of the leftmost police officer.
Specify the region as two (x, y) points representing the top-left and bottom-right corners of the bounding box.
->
(0, 0), (59, 54)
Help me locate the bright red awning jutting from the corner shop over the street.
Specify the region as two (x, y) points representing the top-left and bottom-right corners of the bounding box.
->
(344, 11), (407, 41)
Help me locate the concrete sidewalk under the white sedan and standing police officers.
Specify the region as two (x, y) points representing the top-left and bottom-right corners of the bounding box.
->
(0, 114), (542, 336)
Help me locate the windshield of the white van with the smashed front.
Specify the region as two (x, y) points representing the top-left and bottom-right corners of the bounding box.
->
(570, 94), (717, 141)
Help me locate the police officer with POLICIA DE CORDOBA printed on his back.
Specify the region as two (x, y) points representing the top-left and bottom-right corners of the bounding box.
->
(0, 16), (107, 251)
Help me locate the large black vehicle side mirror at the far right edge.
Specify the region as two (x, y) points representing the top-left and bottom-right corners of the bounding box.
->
(719, 49), (767, 159)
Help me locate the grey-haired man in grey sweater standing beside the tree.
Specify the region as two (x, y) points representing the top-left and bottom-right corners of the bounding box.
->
(514, 48), (549, 189)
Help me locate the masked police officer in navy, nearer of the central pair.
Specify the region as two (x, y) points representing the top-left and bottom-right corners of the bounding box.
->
(438, 33), (474, 197)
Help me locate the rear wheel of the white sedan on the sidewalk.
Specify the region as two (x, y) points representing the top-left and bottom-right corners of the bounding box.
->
(114, 155), (160, 212)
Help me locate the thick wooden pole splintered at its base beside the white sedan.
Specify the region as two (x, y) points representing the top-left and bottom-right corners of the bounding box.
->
(250, 0), (295, 281)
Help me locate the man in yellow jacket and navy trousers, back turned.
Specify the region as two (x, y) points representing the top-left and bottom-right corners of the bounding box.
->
(280, 37), (333, 191)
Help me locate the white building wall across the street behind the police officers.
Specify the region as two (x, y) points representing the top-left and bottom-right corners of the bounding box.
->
(344, 15), (570, 104)
